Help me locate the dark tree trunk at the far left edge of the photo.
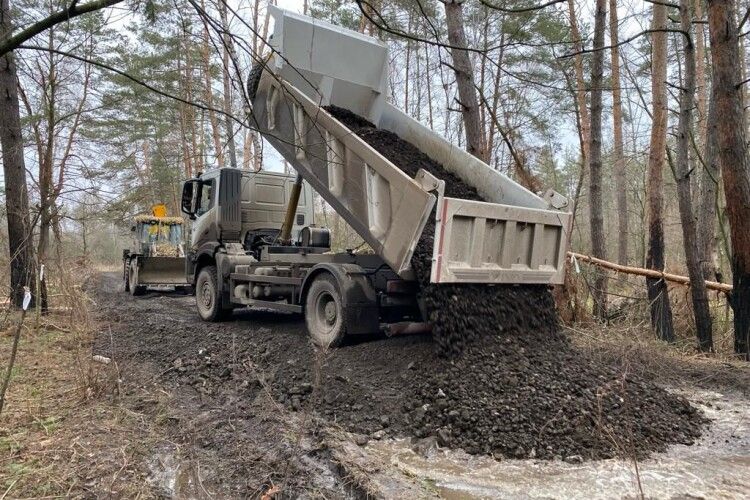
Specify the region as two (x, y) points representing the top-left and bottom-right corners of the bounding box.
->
(0, 0), (35, 307)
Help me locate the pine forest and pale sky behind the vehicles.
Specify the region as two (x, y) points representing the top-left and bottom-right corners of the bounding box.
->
(0, 0), (750, 498)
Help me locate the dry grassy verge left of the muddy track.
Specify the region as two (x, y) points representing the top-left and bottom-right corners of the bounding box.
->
(0, 265), (164, 498)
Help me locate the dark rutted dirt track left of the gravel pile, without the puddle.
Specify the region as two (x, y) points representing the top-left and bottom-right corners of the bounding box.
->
(92, 274), (432, 498)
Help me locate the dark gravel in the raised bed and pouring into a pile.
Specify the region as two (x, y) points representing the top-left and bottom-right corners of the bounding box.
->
(326, 107), (705, 460)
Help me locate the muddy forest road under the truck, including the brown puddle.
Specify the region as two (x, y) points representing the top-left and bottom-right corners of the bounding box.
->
(90, 274), (750, 498)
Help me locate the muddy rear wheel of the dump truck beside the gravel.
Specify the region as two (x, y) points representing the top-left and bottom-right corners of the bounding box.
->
(305, 273), (347, 348)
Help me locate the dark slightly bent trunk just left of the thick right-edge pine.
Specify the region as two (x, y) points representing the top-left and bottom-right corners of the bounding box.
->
(675, 0), (713, 352)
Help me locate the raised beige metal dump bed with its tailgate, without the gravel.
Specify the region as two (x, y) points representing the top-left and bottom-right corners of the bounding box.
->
(249, 7), (571, 284)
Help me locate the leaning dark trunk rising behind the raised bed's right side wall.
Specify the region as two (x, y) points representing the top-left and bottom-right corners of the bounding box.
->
(443, 0), (489, 162)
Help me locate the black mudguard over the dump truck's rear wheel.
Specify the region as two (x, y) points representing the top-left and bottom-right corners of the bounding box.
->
(299, 263), (380, 334)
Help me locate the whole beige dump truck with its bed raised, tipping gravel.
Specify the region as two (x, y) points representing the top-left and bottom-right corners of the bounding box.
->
(182, 6), (571, 346)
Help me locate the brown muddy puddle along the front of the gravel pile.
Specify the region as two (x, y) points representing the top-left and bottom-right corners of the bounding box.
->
(368, 391), (750, 499)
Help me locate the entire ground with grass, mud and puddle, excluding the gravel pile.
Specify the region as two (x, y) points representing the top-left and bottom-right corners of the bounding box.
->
(0, 274), (750, 499)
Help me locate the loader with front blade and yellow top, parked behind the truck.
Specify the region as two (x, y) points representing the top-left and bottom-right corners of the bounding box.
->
(122, 204), (191, 295)
